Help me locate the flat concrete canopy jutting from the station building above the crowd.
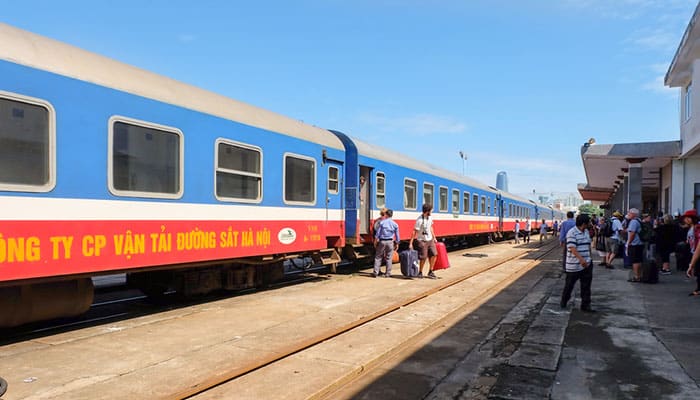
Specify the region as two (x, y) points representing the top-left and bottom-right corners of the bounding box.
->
(578, 140), (681, 203)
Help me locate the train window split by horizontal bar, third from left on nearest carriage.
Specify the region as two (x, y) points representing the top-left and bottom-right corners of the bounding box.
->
(216, 139), (262, 202)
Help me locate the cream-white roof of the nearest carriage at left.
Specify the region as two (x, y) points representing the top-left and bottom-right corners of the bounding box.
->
(0, 23), (343, 150)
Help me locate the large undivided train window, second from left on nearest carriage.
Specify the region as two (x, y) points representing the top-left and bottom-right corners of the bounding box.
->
(108, 117), (183, 198)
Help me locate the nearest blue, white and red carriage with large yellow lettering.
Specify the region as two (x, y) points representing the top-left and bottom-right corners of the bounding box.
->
(0, 24), (345, 327)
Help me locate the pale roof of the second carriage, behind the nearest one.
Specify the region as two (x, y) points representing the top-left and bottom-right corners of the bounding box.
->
(351, 137), (499, 193)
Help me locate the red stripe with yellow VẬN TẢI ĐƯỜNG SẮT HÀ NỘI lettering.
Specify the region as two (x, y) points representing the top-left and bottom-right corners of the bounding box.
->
(0, 221), (344, 281)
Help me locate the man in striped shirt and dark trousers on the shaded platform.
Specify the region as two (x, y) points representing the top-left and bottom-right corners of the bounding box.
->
(560, 214), (595, 312)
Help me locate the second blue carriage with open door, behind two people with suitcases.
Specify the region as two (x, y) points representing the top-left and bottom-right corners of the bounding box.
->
(333, 131), (500, 245)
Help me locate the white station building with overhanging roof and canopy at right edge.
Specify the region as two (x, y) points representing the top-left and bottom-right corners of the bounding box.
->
(578, 4), (700, 214)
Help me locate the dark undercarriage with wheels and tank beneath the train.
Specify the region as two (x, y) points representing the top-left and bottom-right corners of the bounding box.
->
(0, 233), (503, 328)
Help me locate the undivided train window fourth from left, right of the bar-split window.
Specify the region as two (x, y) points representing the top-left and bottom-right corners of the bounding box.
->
(284, 154), (316, 204)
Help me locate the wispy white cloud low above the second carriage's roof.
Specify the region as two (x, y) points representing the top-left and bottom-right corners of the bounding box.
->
(359, 114), (467, 136)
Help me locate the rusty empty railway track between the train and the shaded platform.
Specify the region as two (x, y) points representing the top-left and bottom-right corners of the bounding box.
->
(167, 241), (559, 400)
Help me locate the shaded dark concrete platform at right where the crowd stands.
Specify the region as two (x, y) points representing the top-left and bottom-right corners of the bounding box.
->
(338, 253), (700, 400)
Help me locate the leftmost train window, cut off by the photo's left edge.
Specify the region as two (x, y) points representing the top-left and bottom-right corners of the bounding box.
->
(0, 92), (56, 192)
